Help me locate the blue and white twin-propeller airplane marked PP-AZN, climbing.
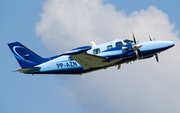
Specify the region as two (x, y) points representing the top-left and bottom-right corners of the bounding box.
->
(8, 34), (175, 75)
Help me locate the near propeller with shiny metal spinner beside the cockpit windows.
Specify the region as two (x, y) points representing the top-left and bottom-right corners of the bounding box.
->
(132, 33), (143, 60)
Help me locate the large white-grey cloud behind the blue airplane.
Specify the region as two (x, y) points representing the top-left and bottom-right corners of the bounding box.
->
(36, 0), (180, 113)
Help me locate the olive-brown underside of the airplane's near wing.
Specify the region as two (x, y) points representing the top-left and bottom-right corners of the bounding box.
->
(70, 53), (108, 69)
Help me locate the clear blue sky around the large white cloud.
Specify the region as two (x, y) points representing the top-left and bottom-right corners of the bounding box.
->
(0, 0), (180, 113)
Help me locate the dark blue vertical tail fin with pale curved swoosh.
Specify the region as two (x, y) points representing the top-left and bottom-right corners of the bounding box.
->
(8, 42), (48, 68)
